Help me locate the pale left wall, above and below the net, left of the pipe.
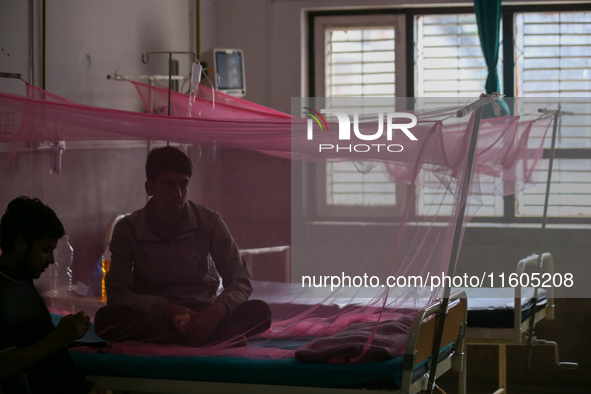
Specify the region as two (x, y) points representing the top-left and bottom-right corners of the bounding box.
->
(0, 0), (197, 283)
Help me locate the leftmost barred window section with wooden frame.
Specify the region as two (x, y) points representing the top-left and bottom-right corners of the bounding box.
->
(315, 15), (405, 217)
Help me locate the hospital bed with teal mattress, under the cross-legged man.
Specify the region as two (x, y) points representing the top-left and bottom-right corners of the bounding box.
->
(66, 291), (467, 394)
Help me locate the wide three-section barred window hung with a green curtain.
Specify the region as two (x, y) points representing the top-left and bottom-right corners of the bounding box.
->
(310, 4), (591, 222)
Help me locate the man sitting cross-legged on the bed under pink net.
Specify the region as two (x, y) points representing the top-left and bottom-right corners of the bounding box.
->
(95, 147), (271, 346)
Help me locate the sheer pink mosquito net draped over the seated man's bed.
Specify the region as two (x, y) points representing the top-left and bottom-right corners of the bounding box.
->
(0, 82), (552, 362)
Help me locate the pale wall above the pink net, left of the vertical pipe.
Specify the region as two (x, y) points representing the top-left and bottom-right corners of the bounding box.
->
(0, 0), (196, 110)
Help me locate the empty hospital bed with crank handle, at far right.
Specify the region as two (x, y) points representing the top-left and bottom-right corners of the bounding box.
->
(459, 253), (577, 394)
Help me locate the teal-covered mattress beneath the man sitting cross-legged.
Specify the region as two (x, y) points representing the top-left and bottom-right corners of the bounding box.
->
(52, 314), (453, 388)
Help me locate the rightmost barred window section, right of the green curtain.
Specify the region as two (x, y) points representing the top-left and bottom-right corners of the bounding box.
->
(515, 12), (591, 218)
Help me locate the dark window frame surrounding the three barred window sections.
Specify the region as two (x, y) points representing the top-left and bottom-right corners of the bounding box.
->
(304, 3), (591, 224)
